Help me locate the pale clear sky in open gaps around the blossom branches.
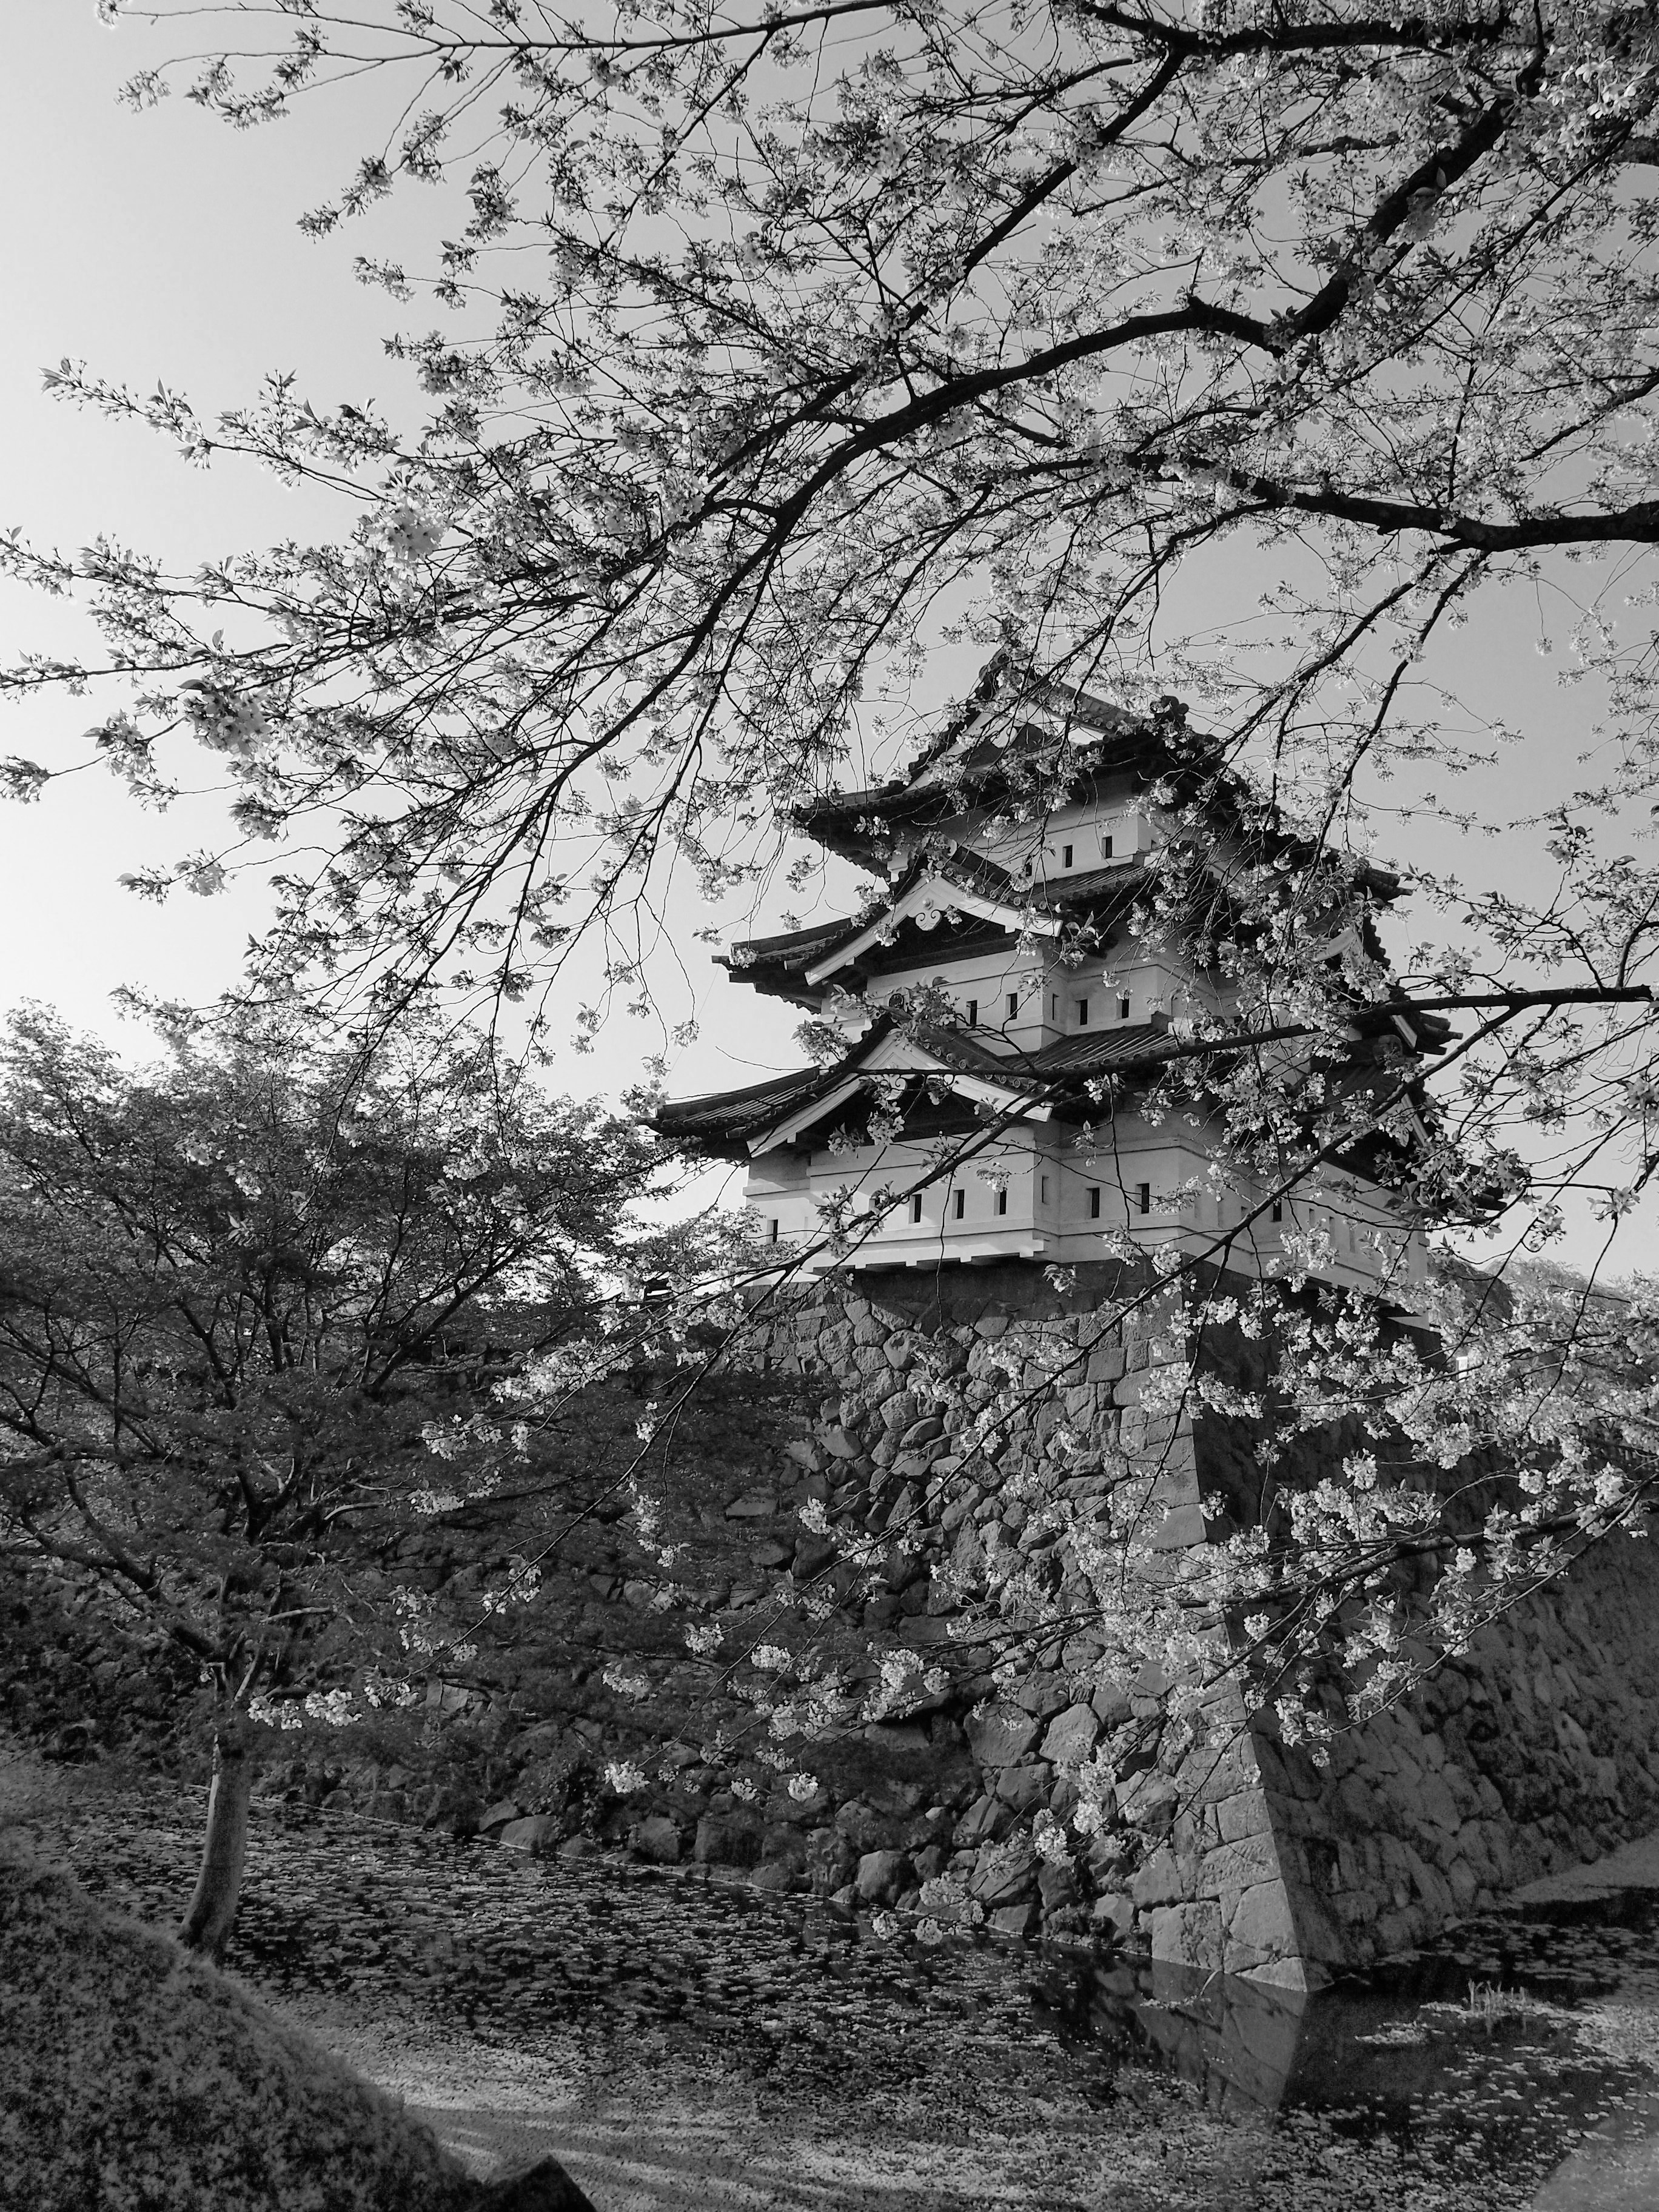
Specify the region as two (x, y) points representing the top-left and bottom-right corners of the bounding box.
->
(0, 0), (1659, 1267)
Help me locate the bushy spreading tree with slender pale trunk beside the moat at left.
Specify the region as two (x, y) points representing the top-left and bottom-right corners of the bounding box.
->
(0, 1013), (681, 1949)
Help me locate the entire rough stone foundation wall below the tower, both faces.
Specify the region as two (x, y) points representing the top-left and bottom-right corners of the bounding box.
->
(35, 1263), (1659, 1989)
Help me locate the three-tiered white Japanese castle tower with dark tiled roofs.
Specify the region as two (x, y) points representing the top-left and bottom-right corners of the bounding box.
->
(655, 663), (1447, 1292)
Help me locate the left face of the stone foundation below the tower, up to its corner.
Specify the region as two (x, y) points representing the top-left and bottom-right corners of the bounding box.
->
(312, 1263), (1301, 1984)
